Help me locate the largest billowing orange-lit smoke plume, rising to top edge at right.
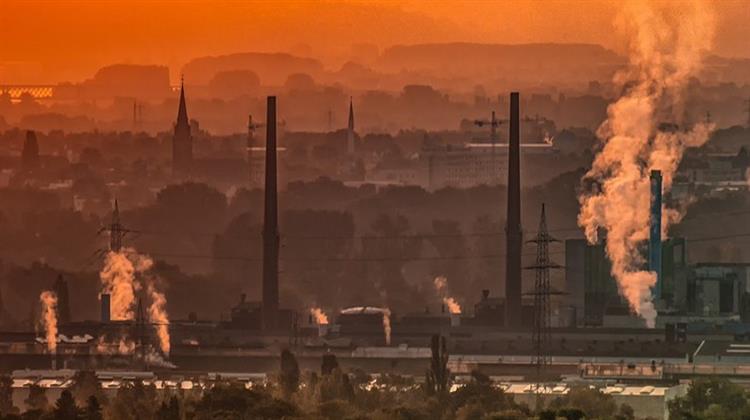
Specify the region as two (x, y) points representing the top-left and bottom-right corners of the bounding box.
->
(578, 1), (715, 328)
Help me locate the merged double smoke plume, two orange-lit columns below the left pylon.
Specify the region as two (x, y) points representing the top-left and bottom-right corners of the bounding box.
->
(99, 248), (171, 356)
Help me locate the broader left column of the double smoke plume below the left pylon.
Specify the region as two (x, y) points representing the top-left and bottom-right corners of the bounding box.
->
(99, 248), (153, 321)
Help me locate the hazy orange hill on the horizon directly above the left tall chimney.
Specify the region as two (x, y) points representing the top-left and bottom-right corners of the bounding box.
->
(182, 52), (323, 86)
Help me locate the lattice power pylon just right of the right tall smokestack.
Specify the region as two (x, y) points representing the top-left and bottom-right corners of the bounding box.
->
(526, 203), (561, 382)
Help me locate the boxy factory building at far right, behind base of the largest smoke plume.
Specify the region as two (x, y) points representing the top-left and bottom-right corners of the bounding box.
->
(564, 238), (750, 326)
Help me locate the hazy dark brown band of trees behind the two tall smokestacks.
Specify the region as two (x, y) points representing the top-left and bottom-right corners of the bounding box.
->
(0, 172), (580, 321)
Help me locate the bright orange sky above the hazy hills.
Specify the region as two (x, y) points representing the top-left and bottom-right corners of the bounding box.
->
(0, 0), (750, 83)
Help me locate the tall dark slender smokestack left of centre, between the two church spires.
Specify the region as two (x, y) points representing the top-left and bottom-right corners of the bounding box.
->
(263, 96), (279, 330)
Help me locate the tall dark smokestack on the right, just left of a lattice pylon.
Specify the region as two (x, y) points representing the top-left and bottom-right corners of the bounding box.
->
(505, 92), (523, 328)
